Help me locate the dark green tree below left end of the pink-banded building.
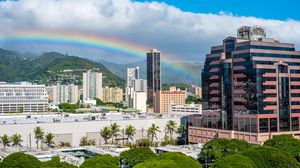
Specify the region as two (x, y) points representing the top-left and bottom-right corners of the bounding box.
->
(200, 138), (252, 164)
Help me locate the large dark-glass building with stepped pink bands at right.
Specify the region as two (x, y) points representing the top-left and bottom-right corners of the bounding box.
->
(189, 26), (300, 144)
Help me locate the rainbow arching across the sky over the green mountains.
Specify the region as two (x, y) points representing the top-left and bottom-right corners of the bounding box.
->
(0, 30), (200, 84)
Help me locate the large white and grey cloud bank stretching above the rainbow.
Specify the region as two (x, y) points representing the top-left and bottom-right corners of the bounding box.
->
(0, 0), (300, 61)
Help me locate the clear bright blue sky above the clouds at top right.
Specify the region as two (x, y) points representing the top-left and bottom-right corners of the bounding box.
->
(138, 0), (300, 20)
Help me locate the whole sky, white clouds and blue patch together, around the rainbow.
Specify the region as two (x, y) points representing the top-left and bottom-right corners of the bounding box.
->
(0, 0), (300, 63)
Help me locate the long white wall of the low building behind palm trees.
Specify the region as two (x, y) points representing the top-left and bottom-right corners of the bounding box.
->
(0, 117), (180, 147)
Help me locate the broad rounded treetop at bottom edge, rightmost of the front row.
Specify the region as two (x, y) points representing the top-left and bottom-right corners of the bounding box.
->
(242, 146), (299, 168)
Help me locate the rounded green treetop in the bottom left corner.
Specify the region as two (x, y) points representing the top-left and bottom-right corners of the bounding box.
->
(0, 152), (42, 168)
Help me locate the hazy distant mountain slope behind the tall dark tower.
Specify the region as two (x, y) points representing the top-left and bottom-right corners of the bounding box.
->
(100, 60), (203, 85)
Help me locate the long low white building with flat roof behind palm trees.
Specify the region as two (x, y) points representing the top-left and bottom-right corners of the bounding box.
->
(0, 113), (180, 148)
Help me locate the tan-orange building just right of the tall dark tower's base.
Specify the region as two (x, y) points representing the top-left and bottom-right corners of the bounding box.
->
(154, 91), (187, 113)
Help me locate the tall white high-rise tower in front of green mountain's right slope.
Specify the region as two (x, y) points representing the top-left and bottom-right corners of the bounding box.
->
(83, 70), (103, 101)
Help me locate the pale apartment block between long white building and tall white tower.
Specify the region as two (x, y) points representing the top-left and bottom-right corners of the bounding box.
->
(46, 84), (79, 104)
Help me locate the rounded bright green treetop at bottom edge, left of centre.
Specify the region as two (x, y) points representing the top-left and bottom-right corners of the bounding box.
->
(80, 155), (119, 168)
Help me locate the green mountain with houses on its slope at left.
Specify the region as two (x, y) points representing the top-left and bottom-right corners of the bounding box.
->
(0, 49), (125, 86)
